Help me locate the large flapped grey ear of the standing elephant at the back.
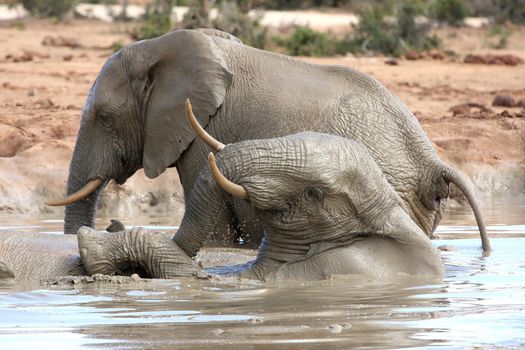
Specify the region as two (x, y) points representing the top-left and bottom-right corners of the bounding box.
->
(143, 30), (232, 178)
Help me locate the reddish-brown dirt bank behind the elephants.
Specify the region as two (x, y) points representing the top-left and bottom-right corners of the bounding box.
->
(0, 20), (525, 216)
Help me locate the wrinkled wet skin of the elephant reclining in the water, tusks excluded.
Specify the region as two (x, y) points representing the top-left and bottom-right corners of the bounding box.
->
(78, 132), (443, 281)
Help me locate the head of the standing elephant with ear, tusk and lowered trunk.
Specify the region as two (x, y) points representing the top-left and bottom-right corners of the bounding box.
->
(48, 30), (231, 234)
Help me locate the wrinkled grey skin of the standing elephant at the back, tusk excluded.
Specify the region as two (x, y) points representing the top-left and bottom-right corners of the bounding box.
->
(64, 30), (489, 250)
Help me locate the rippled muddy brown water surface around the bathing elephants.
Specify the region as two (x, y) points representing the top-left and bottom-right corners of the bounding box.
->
(0, 205), (525, 349)
